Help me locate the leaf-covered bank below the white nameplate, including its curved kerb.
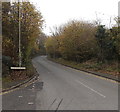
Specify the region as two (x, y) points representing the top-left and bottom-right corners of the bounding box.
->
(0, 60), (38, 92)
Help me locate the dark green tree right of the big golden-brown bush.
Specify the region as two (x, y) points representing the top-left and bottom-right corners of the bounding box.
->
(96, 25), (118, 62)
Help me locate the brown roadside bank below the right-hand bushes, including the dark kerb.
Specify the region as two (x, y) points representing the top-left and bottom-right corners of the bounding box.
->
(48, 58), (120, 82)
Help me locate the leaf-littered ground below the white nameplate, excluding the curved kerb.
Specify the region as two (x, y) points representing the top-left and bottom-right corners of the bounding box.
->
(2, 60), (36, 89)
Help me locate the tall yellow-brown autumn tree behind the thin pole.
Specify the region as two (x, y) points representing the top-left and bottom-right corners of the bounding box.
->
(2, 2), (43, 64)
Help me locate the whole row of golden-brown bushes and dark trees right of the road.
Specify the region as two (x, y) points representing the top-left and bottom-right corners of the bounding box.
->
(46, 21), (120, 63)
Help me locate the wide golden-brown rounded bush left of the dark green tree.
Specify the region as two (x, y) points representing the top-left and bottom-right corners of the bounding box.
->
(46, 21), (96, 62)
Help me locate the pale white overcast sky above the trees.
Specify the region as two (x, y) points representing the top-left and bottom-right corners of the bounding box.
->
(30, 0), (120, 35)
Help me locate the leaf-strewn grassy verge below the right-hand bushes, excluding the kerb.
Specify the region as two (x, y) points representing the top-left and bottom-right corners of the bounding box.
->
(48, 58), (120, 77)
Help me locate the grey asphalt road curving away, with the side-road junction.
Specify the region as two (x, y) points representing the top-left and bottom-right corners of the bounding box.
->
(3, 56), (118, 110)
